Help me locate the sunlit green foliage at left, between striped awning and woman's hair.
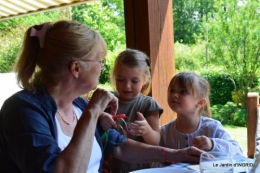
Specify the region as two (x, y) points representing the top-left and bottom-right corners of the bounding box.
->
(0, 9), (66, 73)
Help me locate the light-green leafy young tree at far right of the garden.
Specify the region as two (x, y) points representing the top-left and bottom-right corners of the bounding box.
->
(204, 0), (260, 108)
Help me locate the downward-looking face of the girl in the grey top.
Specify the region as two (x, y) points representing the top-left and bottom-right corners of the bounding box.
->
(115, 65), (145, 101)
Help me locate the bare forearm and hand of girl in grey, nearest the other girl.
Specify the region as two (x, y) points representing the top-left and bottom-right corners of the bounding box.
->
(129, 112), (160, 145)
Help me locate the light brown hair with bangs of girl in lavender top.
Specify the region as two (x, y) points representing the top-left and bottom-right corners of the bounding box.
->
(168, 72), (211, 117)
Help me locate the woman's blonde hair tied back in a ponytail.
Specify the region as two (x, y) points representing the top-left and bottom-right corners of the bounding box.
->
(15, 20), (107, 90)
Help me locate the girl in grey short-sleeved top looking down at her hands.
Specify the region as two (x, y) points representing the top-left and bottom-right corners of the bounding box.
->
(99, 49), (163, 173)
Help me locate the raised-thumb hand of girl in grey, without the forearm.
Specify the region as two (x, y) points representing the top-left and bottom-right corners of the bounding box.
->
(128, 112), (152, 136)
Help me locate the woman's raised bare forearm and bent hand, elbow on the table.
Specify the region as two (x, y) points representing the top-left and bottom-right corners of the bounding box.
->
(54, 89), (118, 173)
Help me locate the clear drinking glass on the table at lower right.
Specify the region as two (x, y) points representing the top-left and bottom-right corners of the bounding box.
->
(200, 152), (233, 173)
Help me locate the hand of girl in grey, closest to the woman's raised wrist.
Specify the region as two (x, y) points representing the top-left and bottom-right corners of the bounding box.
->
(99, 112), (116, 131)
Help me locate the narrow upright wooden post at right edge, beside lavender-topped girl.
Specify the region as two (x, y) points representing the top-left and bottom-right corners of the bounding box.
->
(247, 92), (259, 158)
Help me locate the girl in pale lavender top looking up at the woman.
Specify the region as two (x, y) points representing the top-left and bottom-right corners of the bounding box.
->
(160, 72), (242, 155)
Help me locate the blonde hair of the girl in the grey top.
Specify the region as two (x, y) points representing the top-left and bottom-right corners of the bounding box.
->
(110, 49), (151, 95)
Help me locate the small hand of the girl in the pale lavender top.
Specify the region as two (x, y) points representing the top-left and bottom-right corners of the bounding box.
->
(191, 136), (213, 151)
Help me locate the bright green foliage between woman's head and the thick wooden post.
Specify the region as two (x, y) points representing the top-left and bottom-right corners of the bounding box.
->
(72, 0), (126, 84)
